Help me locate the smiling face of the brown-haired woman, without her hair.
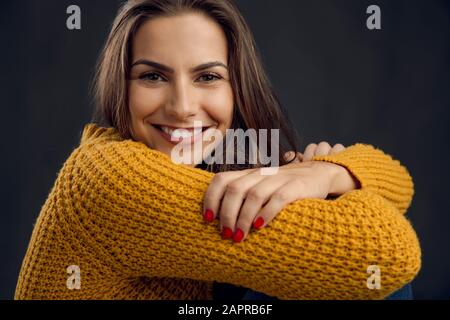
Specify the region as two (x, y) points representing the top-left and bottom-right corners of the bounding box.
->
(128, 13), (234, 166)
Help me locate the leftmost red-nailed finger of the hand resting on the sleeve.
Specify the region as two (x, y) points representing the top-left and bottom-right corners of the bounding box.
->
(203, 170), (245, 222)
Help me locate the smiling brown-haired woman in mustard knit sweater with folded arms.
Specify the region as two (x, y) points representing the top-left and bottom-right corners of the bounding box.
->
(15, 0), (421, 299)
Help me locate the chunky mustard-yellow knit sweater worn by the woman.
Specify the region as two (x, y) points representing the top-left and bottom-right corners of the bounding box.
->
(15, 124), (421, 299)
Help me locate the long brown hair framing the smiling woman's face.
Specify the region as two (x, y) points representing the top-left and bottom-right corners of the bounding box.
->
(92, 0), (298, 172)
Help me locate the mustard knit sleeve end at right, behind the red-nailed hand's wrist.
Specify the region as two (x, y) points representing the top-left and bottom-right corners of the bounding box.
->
(312, 143), (414, 214)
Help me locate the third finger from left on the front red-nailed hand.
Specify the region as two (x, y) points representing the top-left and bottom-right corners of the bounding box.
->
(233, 177), (289, 242)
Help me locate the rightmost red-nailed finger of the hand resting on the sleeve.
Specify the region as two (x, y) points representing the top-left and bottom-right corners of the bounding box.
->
(253, 180), (304, 229)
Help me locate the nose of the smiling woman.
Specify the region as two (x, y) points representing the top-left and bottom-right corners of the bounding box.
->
(166, 80), (198, 120)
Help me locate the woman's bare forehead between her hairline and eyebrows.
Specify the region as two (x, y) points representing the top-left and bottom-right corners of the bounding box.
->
(132, 13), (228, 63)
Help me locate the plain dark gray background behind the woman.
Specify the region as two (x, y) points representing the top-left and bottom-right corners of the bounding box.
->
(0, 0), (450, 299)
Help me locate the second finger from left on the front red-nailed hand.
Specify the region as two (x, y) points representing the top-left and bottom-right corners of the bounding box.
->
(219, 172), (264, 238)
